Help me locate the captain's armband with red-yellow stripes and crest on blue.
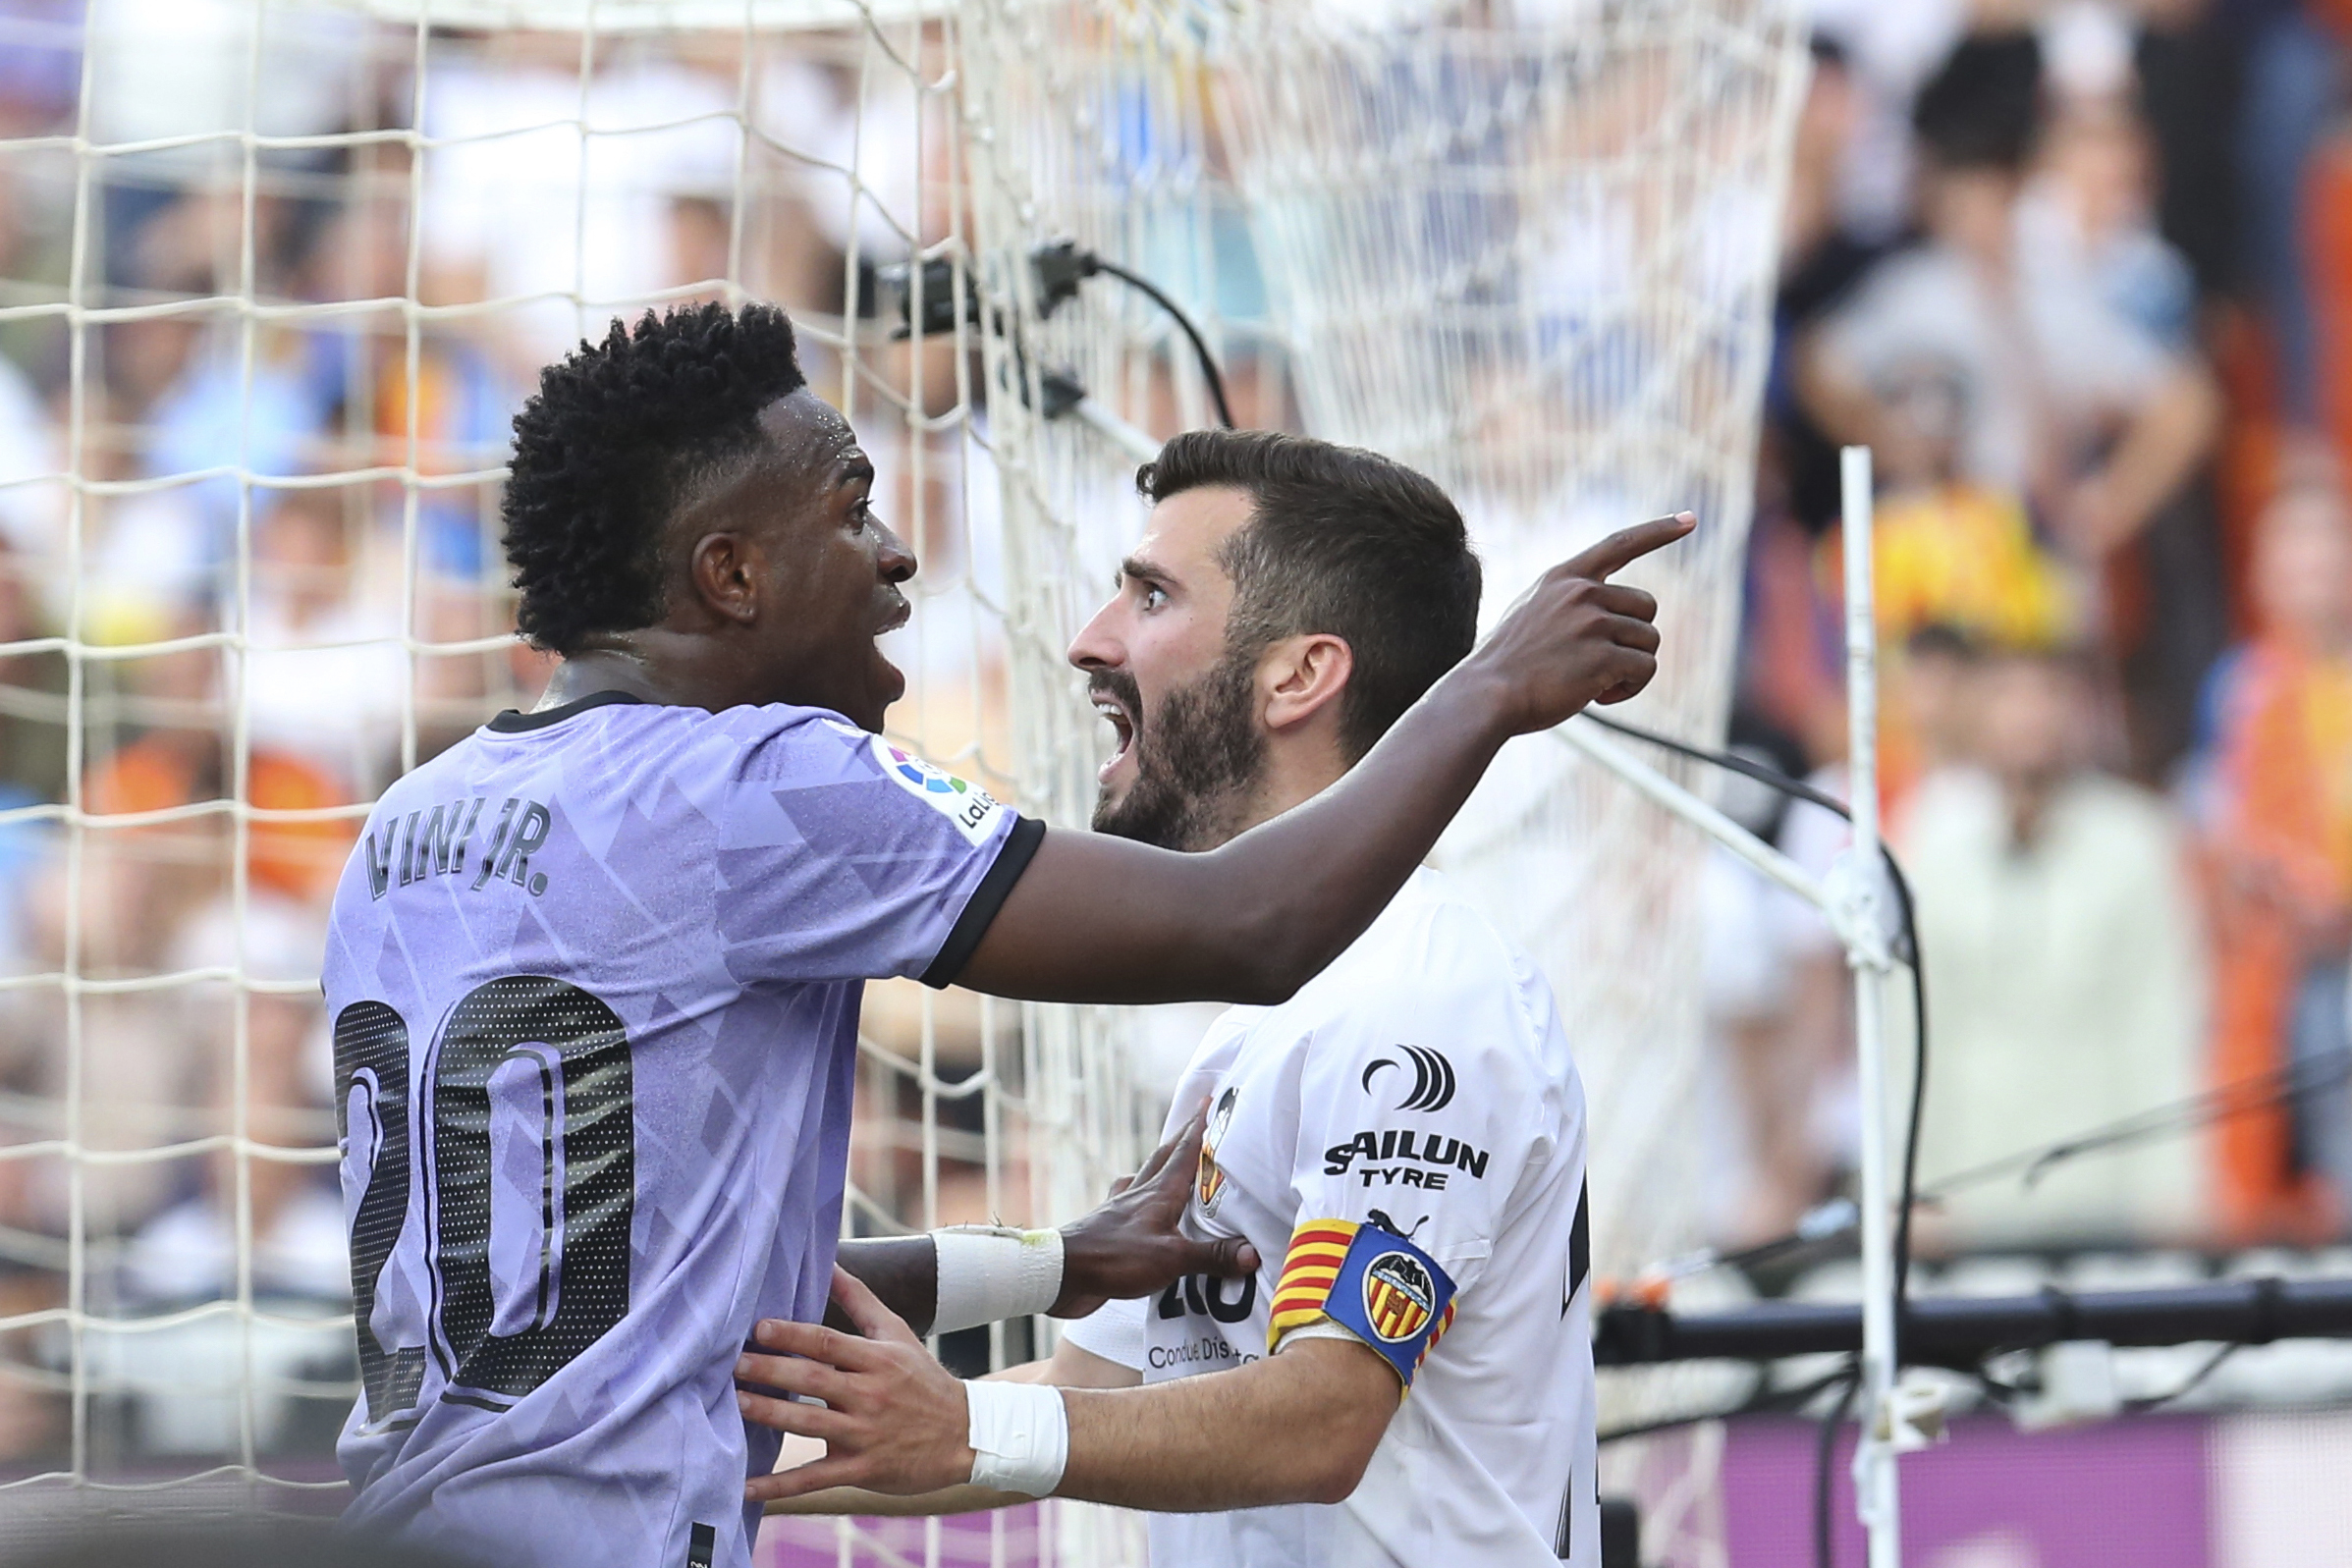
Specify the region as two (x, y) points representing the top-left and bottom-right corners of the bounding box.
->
(1268, 1220), (1453, 1387)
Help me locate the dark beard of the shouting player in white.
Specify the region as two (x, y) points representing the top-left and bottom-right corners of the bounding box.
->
(1089, 651), (1266, 851)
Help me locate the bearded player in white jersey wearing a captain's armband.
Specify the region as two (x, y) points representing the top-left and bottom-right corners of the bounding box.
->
(740, 433), (1600, 1568)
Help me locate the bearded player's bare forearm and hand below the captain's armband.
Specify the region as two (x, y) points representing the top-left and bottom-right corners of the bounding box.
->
(737, 1279), (1397, 1512)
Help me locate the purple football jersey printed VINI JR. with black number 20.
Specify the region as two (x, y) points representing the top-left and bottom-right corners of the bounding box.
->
(325, 691), (1044, 1568)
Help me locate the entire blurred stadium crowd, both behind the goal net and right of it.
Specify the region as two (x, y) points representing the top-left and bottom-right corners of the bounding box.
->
(0, 0), (2352, 1462)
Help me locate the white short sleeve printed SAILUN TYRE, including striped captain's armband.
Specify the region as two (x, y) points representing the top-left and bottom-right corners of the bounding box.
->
(1268, 905), (1546, 1387)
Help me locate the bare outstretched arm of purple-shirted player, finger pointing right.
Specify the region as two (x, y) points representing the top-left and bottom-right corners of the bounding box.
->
(957, 513), (1693, 1001)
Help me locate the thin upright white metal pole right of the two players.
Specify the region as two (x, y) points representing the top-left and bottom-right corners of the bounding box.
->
(1839, 447), (1903, 1568)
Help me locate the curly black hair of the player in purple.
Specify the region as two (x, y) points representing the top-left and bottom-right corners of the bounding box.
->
(499, 303), (806, 654)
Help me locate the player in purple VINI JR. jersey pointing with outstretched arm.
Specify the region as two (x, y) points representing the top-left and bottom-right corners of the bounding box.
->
(325, 305), (1691, 1568)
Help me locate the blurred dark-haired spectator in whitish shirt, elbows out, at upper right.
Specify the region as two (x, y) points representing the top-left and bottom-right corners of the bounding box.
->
(1802, 35), (2214, 575)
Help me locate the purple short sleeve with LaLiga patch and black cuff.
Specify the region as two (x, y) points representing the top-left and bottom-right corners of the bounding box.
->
(703, 710), (1044, 985)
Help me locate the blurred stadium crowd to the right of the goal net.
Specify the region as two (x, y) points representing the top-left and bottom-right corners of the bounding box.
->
(1710, 0), (2352, 1244)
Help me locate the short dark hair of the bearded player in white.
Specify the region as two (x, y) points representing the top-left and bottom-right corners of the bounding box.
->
(1136, 430), (1479, 762)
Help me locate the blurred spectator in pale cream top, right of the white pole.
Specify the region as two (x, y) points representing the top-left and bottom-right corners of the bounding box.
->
(1895, 651), (2204, 1244)
